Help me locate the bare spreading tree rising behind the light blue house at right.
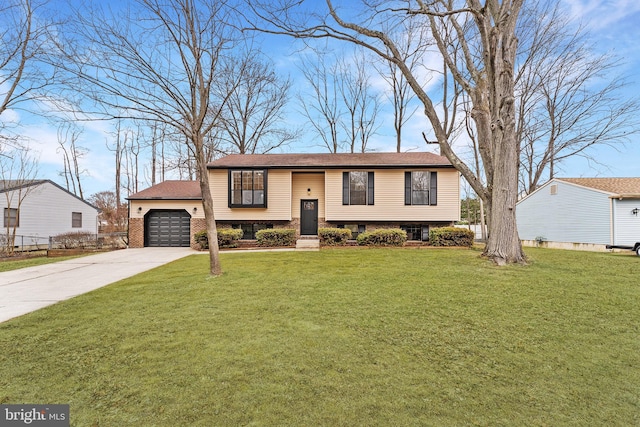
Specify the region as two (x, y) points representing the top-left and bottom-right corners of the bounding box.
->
(516, 2), (640, 193)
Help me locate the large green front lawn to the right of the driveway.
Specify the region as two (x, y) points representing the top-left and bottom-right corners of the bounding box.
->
(0, 249), (640, 426)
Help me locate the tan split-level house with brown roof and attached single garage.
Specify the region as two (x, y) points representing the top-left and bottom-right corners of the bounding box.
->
(128, 152), (460, 247)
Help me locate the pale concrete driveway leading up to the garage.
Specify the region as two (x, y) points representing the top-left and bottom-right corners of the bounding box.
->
(0, 248), (198, 322)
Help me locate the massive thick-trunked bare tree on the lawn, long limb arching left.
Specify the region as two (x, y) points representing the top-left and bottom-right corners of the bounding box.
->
(250, 0), (525, 264)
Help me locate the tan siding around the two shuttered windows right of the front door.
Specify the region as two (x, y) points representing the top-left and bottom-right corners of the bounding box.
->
(325, 169), (460, 222)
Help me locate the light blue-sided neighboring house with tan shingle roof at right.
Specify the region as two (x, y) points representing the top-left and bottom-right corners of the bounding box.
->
(516, 178), (640, 250)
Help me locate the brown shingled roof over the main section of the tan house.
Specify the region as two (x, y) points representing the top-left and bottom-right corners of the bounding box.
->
(207, 152), (453, 169)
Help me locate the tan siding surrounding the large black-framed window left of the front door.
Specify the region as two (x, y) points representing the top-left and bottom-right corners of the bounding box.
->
(209, 169), (291, 221)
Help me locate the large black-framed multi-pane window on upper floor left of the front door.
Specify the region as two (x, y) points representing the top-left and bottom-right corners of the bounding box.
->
(229, 169), (267, 208)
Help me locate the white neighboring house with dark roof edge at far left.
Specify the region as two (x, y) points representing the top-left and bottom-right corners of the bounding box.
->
(0, 180), (99, 246)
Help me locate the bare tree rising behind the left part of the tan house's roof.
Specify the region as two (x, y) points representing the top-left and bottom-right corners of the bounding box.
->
(218, 51), (300, 154)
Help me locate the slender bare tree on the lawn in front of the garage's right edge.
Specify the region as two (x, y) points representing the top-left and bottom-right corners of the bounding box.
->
(60, 0), (248, 275)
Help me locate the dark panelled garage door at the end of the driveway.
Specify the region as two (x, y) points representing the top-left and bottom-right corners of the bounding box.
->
(144, 210), (191, 247)
